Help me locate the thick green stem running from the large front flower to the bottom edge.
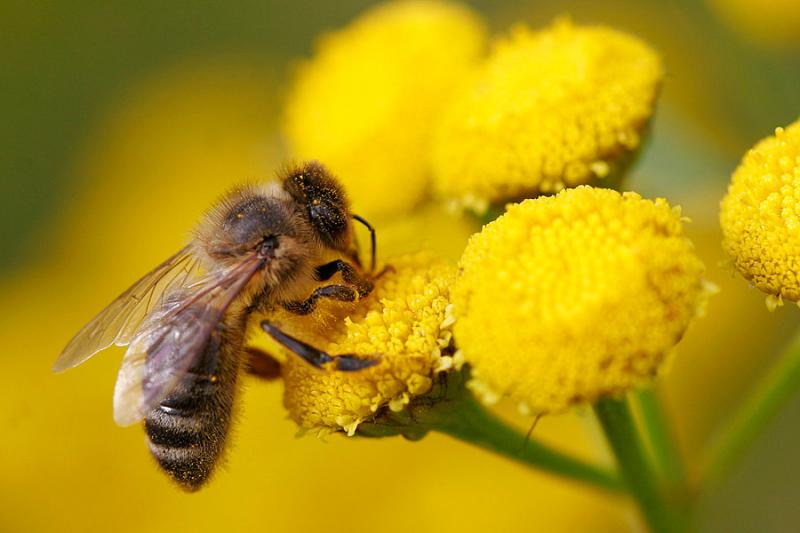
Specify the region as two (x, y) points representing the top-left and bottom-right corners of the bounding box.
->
(594, 398), (683, 533)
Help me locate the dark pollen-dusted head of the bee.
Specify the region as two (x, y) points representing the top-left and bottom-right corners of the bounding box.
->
(283, 161), (352, 251)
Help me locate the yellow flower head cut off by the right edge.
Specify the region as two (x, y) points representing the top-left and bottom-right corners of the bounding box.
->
(720, 121), (800, 302)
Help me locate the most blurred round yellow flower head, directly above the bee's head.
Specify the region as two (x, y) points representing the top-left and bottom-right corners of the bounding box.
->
(283, 1), (486, 215)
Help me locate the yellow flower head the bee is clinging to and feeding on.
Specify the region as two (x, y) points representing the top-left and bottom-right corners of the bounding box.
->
(276, 254), (455, 434)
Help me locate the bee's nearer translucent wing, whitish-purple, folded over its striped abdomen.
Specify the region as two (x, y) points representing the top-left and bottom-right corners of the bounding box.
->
(114, 256), (263, 426)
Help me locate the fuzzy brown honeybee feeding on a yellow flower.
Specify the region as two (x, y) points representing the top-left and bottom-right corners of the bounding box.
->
(53, 162), (377, 491)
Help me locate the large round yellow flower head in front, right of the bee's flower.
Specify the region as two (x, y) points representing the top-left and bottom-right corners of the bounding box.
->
(452, 186), (705, 414)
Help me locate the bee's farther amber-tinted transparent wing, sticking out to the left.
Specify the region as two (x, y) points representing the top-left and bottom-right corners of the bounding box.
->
(53, 246), (196, 372)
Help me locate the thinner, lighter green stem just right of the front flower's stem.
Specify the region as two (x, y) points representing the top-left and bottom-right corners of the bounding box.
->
(635, 388), (689, 494)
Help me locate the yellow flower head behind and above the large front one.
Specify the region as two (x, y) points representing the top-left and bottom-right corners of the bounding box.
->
(432, 19), (663, 211)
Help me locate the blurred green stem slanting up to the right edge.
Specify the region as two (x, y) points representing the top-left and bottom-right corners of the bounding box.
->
(703, 324), (800, 489)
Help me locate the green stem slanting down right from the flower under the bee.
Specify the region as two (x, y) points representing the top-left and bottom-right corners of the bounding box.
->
(423, 393), (623, 491)
